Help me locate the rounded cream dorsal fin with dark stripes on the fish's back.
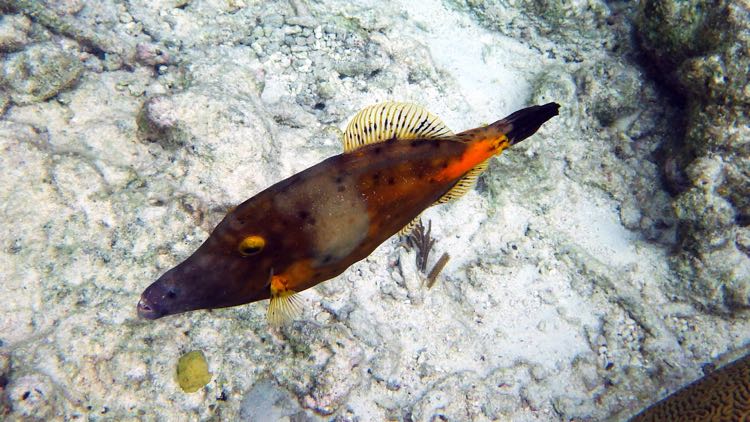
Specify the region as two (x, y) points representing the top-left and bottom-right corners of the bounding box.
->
(343, 103), (453, 152)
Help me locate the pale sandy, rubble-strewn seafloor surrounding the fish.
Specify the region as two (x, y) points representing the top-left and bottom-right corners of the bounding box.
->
(0, 0), (750, 421)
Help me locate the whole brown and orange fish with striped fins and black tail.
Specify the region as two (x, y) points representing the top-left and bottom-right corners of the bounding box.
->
(137, 102), (560, 325)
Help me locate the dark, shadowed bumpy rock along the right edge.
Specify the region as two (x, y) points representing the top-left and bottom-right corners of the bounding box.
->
(637, 0), (750, 313)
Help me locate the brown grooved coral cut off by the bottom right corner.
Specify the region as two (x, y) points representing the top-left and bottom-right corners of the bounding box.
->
(630, 355), (750, 422)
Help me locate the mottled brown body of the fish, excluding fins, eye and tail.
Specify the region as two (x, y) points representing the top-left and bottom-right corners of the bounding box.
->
(137, 140), (467, 314)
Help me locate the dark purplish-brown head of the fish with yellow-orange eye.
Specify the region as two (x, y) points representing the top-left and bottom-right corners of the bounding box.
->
(137, 203), (286, 319)
